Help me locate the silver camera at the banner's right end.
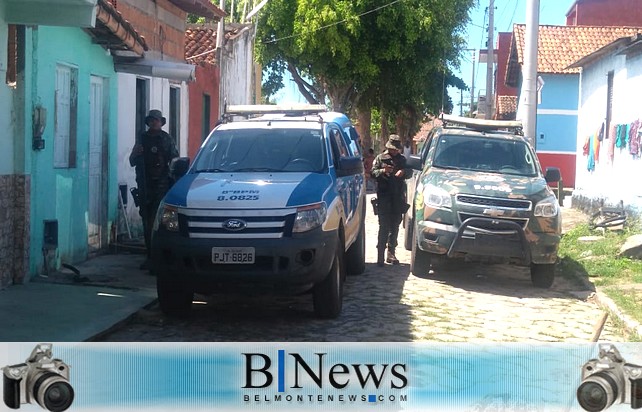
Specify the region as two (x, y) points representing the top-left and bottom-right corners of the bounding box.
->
(577, 343), (642, 412)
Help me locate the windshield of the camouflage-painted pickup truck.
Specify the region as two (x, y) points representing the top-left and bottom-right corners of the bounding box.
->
(433, 135), (537, 176)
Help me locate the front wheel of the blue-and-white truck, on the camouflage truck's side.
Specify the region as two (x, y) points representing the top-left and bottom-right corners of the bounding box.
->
(313, 244), (344, 319)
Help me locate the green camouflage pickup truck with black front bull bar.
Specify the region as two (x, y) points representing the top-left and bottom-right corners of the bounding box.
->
(404, 115), (562, 288)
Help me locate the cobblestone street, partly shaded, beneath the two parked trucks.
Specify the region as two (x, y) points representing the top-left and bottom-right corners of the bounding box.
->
(104, 195), (626, 342)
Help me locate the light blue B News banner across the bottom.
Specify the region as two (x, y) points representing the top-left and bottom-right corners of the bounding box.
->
(0, 343), (642, 412)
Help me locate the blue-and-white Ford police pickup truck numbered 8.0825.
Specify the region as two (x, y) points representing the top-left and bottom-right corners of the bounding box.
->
(151, 105), (366, 318)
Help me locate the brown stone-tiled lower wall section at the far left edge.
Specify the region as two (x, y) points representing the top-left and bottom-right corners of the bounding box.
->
(0, 175), (31, 289)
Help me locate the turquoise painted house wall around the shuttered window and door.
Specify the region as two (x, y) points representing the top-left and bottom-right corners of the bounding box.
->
(27, 26), (118, 275)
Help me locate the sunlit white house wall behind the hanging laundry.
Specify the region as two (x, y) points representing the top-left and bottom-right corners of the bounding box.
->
(573, 51), (642, 209)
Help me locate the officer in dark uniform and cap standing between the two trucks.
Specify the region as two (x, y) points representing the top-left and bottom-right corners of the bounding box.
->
(372, 134), (412, 266)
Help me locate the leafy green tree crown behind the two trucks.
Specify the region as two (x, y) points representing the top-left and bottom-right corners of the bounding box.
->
(256, 0), (474, 115)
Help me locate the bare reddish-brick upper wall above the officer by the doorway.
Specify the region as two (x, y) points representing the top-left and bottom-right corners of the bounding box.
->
(118, 0), (187, 61)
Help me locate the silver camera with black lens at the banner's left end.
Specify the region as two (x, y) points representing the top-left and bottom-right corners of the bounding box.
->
(2, 343), (74, 412)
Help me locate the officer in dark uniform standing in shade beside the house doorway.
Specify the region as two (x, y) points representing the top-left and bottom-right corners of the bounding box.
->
(129, 110), (178, 269)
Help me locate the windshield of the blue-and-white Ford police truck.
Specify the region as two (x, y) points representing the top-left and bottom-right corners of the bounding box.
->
(192, 128), (326, 172)
